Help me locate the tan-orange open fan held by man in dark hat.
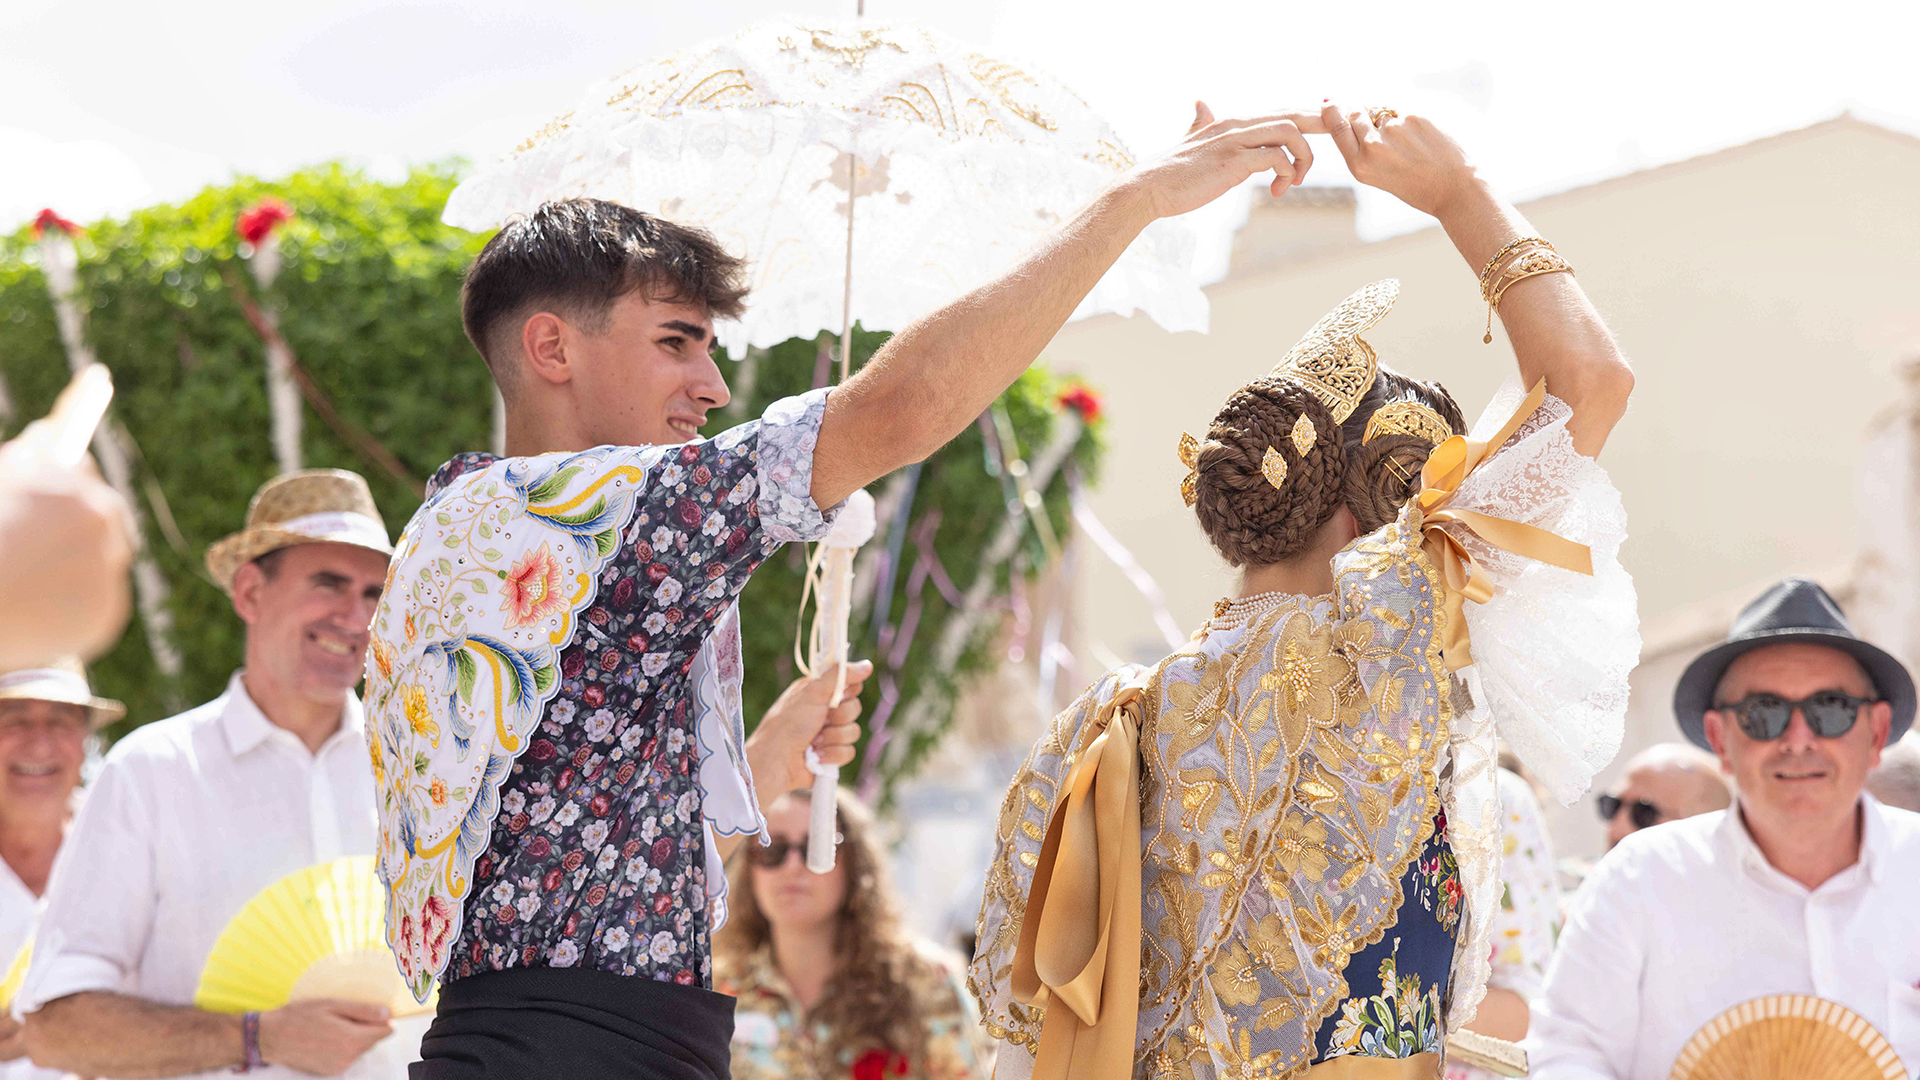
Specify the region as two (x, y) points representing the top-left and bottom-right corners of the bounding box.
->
(1670, 994), (1907, 1080)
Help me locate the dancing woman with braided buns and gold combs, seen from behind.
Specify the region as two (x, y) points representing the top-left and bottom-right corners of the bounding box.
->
(970, 104), (1640, 1080)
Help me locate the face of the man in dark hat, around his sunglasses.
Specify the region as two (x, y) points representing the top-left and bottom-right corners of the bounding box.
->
(1707, 644), (1893, 824)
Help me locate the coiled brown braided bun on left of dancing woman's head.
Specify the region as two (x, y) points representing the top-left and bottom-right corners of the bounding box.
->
(1194, 379), (1348, 567)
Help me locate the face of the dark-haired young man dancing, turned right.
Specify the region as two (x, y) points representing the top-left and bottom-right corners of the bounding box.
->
(564, 288), (730, 446)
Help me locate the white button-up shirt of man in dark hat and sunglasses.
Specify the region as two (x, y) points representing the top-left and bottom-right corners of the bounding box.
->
(1526, 796), (1920, 1080)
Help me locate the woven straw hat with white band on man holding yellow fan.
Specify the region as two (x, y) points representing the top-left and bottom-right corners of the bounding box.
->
(207, 469), (394, 594)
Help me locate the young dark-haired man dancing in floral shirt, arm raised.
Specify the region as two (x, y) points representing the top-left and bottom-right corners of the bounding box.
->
(367, 106), (1321, 1080)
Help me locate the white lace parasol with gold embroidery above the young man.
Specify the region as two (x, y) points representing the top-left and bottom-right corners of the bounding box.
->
(445, 21), (1208, 356)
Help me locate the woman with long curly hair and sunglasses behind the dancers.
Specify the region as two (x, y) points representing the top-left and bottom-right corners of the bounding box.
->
(714, 788), (991, 1080)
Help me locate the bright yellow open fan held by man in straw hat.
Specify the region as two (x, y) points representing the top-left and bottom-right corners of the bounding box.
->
(194, 855), (434, 1017)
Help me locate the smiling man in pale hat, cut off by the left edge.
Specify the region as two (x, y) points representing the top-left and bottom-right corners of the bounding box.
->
(0, 657), (127, 1080)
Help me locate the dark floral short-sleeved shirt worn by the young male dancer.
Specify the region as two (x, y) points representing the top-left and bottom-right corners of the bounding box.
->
(419, 390), (829, 986)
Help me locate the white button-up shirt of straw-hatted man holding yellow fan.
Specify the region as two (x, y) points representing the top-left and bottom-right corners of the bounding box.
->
(13, 673), (426, 1080)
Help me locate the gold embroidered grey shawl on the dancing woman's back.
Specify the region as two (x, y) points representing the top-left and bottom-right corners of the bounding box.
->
(968, 507), (1453, 1078)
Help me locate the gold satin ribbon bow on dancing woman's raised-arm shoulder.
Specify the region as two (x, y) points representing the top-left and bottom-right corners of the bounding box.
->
(1415, 379), (1594, 671)
